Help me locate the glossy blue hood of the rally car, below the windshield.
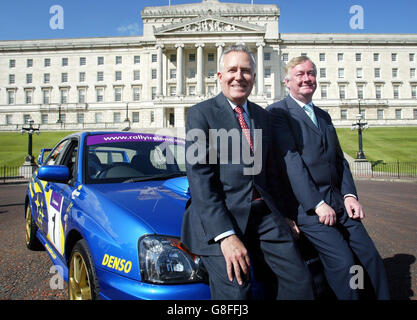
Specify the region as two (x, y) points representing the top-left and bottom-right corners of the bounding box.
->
(89, 177), (189, 236)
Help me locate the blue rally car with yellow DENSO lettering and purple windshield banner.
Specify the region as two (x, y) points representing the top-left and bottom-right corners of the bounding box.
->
(25, 132), (210, 299)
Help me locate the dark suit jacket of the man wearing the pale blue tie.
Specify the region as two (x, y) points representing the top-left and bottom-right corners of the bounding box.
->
(266, 96), (357, 224)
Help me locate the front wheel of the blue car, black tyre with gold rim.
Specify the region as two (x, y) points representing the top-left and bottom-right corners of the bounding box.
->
(68, 239), (99, 300)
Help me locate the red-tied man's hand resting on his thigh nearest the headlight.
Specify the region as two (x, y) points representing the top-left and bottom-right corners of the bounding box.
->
(220, 235), (250, 285)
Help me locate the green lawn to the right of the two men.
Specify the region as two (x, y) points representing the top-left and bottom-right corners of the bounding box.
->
(337, 127), (417, 162)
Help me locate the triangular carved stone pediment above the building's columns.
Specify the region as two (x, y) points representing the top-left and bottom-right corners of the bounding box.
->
(154, 16), (265, 36)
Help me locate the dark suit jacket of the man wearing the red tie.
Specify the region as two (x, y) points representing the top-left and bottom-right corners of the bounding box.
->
(181, 93), (290, 255)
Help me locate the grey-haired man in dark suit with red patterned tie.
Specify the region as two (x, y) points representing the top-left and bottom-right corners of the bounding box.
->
(182, 45), (313, 299)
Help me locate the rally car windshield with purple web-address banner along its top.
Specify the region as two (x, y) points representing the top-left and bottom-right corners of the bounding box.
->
(84, 133), (185, 183)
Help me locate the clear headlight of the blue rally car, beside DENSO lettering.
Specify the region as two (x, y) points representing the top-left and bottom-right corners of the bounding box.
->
(139, 235), (204, 284)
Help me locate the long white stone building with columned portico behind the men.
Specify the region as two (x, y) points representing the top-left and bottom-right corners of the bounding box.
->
(0, 0), (417, 135)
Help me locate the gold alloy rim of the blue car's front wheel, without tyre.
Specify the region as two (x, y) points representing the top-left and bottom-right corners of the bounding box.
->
(68, 252), (92, 300)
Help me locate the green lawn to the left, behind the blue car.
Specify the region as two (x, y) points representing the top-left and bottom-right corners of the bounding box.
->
(0, 132), (76, 167)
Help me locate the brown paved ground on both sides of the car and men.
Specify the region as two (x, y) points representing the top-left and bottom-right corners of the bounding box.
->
(0, 180), (417, 300)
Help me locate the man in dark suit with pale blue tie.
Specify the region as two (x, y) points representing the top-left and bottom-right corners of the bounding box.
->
(267, 57), (389, 299)
